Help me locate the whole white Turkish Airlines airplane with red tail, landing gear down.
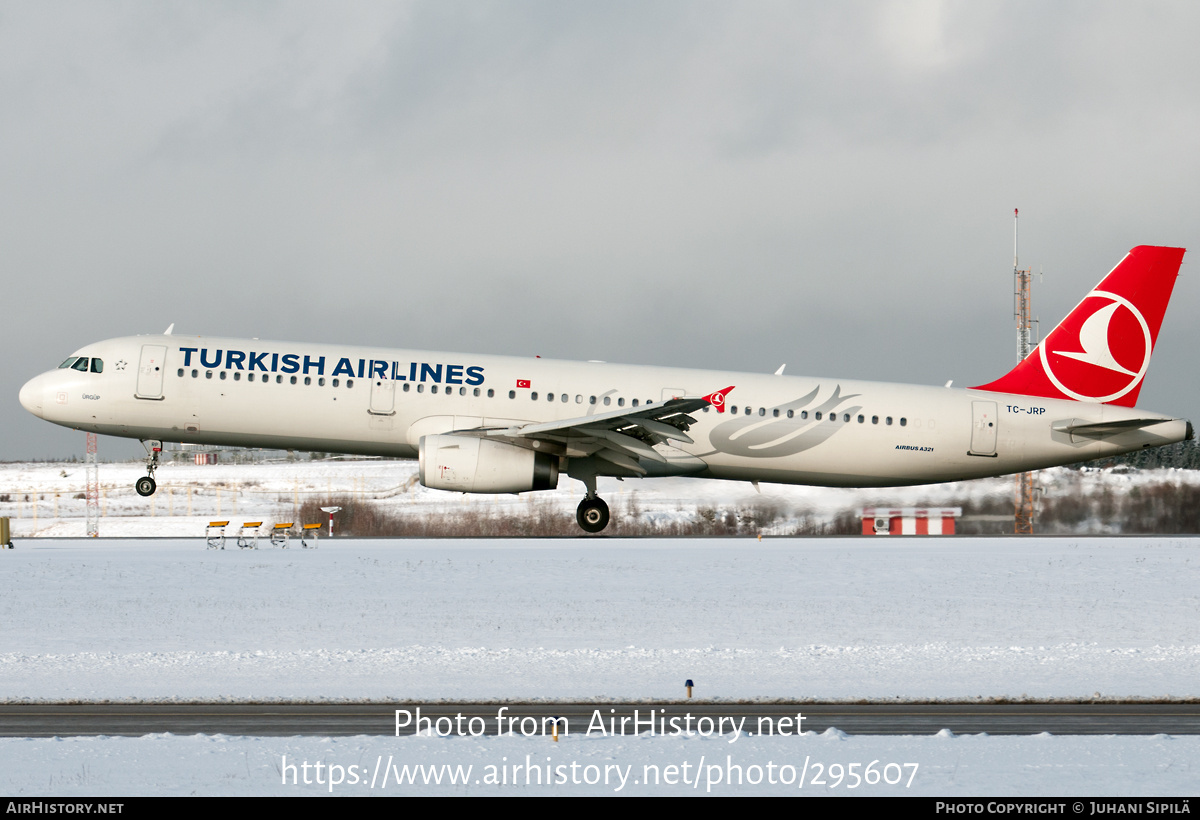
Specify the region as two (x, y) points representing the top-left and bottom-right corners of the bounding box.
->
(20, 246), (1193, 533)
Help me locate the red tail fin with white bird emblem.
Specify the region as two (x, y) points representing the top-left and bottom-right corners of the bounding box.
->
(974, 245), (1184, 407)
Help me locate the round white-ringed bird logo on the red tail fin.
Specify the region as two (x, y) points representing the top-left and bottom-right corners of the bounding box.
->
(1039, 291), (1153, 403)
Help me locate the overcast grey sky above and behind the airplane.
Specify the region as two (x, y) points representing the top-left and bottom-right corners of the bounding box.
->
(0, 0), (1200, 459)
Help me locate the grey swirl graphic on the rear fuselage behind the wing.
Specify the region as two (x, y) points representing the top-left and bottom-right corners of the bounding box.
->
(704, 384), (862, 459)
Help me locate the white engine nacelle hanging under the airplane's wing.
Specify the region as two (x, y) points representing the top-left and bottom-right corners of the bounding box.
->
(418, 436), (558, 492)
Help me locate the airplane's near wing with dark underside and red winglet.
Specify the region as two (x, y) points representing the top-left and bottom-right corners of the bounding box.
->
(454, 387), (733, 475)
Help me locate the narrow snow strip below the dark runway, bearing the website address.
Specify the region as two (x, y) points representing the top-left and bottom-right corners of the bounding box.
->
(9, 730), (1200, 797)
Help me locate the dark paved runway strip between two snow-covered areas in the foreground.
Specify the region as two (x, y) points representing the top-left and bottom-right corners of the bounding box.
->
(0, 701), (1200, 737)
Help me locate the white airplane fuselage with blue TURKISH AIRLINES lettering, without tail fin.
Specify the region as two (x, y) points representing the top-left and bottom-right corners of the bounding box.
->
(20, 336), (1188, 486)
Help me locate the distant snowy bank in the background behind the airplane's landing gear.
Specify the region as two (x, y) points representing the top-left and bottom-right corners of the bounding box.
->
(0, 454), (1200, 538)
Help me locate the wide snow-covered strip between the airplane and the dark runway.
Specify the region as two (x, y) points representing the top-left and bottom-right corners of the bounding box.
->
(0, 538), (1200, 700)
